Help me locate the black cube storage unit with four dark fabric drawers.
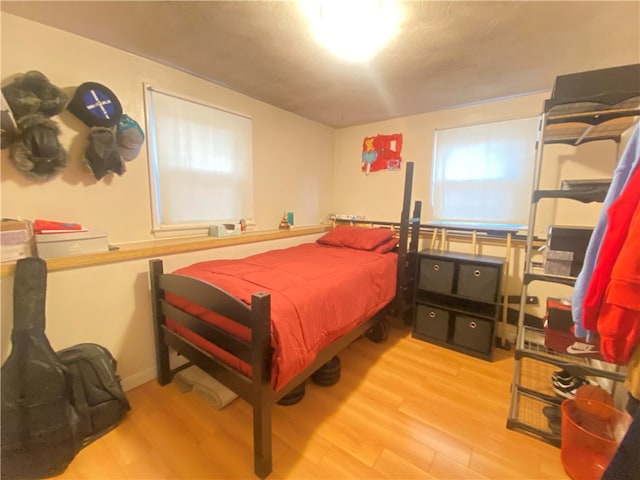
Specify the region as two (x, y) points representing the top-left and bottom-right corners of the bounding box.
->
(412, 250), (504, 360)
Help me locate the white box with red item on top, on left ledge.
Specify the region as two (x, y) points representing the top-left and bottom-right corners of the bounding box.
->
(34, 230), (109, 258)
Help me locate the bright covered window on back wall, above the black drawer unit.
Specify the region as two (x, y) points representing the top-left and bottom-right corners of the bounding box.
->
(431, 117), (538, 230)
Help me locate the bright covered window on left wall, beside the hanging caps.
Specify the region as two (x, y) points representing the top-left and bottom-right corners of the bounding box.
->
(146, 86), (253, 235)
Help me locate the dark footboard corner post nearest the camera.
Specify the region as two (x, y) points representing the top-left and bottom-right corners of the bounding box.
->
(251, 293), (273, 478)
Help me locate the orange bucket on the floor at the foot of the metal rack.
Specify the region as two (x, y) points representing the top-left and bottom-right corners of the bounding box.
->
(560, 398), (631, 480)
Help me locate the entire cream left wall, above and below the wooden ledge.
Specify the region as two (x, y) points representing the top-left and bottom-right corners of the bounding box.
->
(0, 13), (334, 388)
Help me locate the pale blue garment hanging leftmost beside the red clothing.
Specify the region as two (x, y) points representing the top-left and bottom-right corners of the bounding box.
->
(571, 123), (640, 338)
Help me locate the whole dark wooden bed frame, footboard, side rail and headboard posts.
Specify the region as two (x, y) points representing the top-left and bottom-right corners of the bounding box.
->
(149, 162), (421, 478)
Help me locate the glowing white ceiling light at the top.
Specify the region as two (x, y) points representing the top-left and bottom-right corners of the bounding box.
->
(300, 0), (402, 62)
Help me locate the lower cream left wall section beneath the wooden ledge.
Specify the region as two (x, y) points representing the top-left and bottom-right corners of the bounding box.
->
(0, 235), (319, 389)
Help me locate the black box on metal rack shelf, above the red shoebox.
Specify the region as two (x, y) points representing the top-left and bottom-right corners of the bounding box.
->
(544, 225), (593, 277)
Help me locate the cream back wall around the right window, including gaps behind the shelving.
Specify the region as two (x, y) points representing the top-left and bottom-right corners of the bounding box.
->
(333, 94), (622, 326)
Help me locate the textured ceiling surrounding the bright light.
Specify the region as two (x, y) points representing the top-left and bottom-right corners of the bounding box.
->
(0, 0), (640, 128)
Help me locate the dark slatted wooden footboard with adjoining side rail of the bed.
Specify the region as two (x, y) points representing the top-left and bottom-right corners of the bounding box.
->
(149, 260), (390, 478)
